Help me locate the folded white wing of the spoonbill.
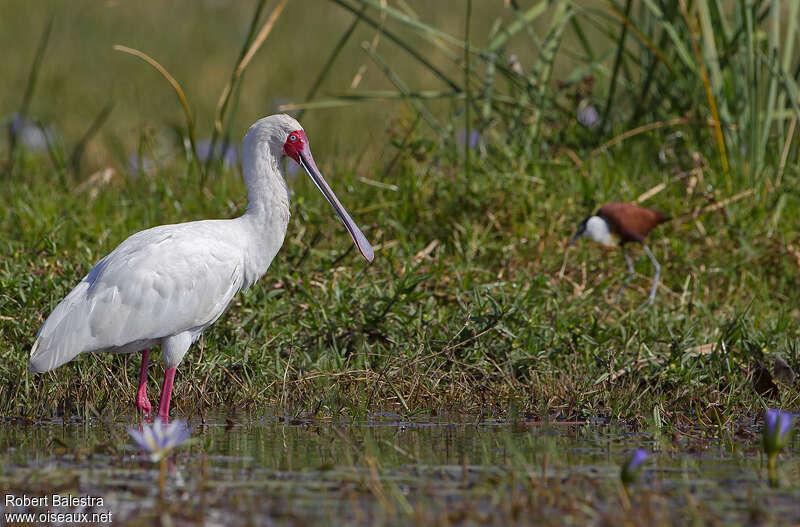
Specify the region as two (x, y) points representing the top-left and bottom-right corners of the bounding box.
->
(30, 220), (244, 372)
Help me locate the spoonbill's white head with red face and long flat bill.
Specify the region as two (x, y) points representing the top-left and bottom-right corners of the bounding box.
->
(242, 114), (374, 262)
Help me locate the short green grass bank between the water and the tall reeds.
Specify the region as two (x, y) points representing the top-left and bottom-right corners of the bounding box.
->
(0, 125), (800, 422)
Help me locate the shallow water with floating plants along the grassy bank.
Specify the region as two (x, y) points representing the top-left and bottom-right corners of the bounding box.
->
(0, 414), (800, 525)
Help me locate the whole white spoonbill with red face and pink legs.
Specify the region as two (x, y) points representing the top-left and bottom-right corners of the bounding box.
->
(29, 115), (373, 419)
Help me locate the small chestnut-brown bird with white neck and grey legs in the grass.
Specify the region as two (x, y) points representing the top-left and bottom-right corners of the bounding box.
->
(567, 202), (670, 304)
